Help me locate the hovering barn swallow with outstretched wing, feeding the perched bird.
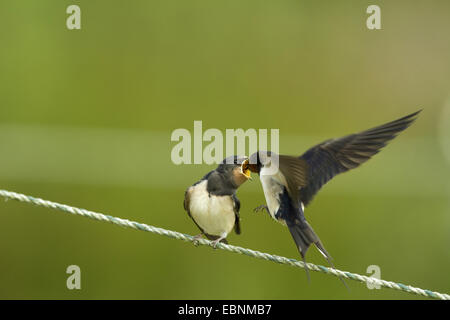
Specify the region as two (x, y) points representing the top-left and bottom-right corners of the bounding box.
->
(243, 111), (420, 279)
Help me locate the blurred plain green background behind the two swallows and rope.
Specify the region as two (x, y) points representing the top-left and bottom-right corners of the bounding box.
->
(0, 0), (450, 299)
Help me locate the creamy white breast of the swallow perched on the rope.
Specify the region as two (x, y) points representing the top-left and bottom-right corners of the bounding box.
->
(189, 180), (236, 236)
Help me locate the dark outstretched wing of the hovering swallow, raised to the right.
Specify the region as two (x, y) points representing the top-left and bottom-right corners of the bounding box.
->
(299, 111), (420, 206)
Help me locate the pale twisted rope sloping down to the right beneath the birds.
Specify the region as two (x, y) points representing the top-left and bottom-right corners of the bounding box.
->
(0, 190), (450, 300)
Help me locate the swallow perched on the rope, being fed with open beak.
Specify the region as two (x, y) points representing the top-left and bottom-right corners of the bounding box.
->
(184, 156), (250, 248)
